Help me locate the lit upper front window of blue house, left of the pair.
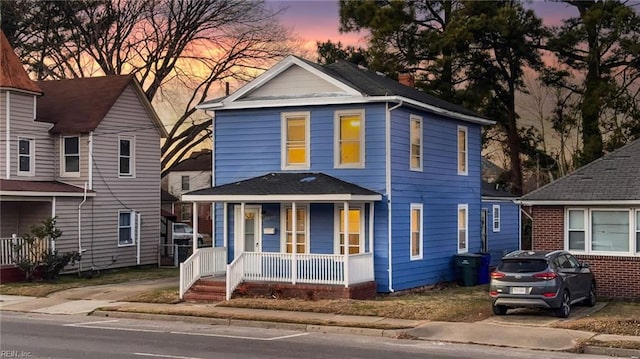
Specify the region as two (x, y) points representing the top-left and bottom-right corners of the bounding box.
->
(281, 112), (311, 169)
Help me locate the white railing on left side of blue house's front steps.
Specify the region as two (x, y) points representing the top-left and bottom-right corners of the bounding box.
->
(180, 247), (227, 299)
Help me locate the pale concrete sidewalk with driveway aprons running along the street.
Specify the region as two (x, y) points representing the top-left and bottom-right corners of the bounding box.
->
(0, 278), (640, 358)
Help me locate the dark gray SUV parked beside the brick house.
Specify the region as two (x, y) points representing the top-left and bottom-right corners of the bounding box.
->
(489, 251), (596, 318)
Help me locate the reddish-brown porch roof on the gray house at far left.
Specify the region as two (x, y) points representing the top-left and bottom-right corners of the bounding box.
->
(0, 179), (96, 197)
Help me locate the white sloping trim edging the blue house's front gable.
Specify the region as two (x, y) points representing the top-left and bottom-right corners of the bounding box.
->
(212, 56), (361, 105)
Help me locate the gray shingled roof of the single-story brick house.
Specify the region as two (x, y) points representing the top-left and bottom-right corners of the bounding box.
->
(522, 140), (640, 201)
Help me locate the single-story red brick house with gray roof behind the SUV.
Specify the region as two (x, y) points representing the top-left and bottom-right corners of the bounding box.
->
(522, 140), (640, 299)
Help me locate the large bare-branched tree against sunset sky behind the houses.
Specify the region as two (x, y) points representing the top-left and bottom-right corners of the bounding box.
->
(6, 0), (291, 175)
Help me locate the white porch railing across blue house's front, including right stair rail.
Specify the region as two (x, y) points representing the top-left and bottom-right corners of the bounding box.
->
(227, 252), (374, 300)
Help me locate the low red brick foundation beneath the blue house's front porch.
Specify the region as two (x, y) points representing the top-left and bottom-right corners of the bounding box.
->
(233, 282), (377, 300)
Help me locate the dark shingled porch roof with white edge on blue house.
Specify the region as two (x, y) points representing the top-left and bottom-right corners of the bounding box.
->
(182, 172), (382, 203)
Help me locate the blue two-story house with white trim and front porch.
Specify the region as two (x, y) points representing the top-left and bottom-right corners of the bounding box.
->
(181, 56), (493, 298)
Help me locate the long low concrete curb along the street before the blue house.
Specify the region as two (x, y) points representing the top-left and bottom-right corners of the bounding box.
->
(89, 310), (402, 338)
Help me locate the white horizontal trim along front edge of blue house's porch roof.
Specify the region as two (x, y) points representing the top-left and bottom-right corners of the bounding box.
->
(181, 194), (382, 203)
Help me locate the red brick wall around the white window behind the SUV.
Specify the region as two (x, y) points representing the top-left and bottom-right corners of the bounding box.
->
(531, 206), (640, 299)
